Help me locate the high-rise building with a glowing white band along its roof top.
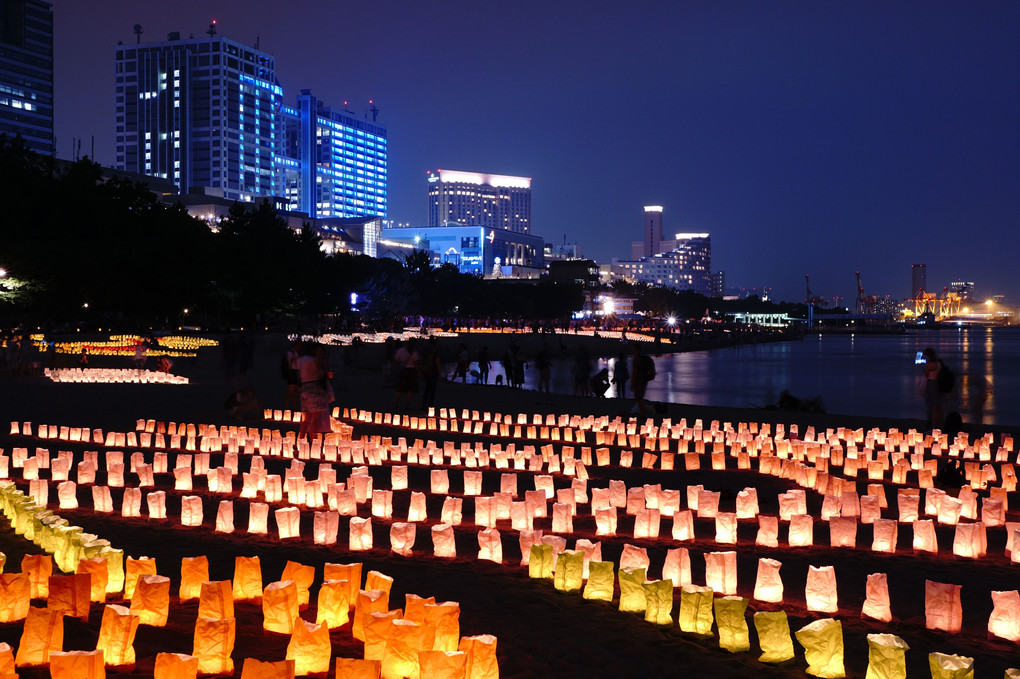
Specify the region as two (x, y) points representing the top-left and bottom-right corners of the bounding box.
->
(428, 169), (531, 233)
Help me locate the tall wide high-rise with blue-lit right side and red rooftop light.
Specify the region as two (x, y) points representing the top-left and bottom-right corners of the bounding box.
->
(115, 31), (283, 201)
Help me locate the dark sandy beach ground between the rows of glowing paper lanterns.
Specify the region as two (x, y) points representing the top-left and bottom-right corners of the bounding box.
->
(0, 334), (1020, 679)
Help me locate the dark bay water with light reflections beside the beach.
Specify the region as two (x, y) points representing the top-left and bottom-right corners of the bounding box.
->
(491, 327), (1020, 425)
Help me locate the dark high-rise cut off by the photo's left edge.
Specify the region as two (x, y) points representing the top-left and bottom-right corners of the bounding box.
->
(0, 0), (55, 156)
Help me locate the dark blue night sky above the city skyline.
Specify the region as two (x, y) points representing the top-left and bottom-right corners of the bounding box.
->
(53, 0), (1020, 305)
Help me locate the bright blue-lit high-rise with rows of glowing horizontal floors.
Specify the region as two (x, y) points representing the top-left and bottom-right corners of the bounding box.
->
(276, 90), (387, 217)
